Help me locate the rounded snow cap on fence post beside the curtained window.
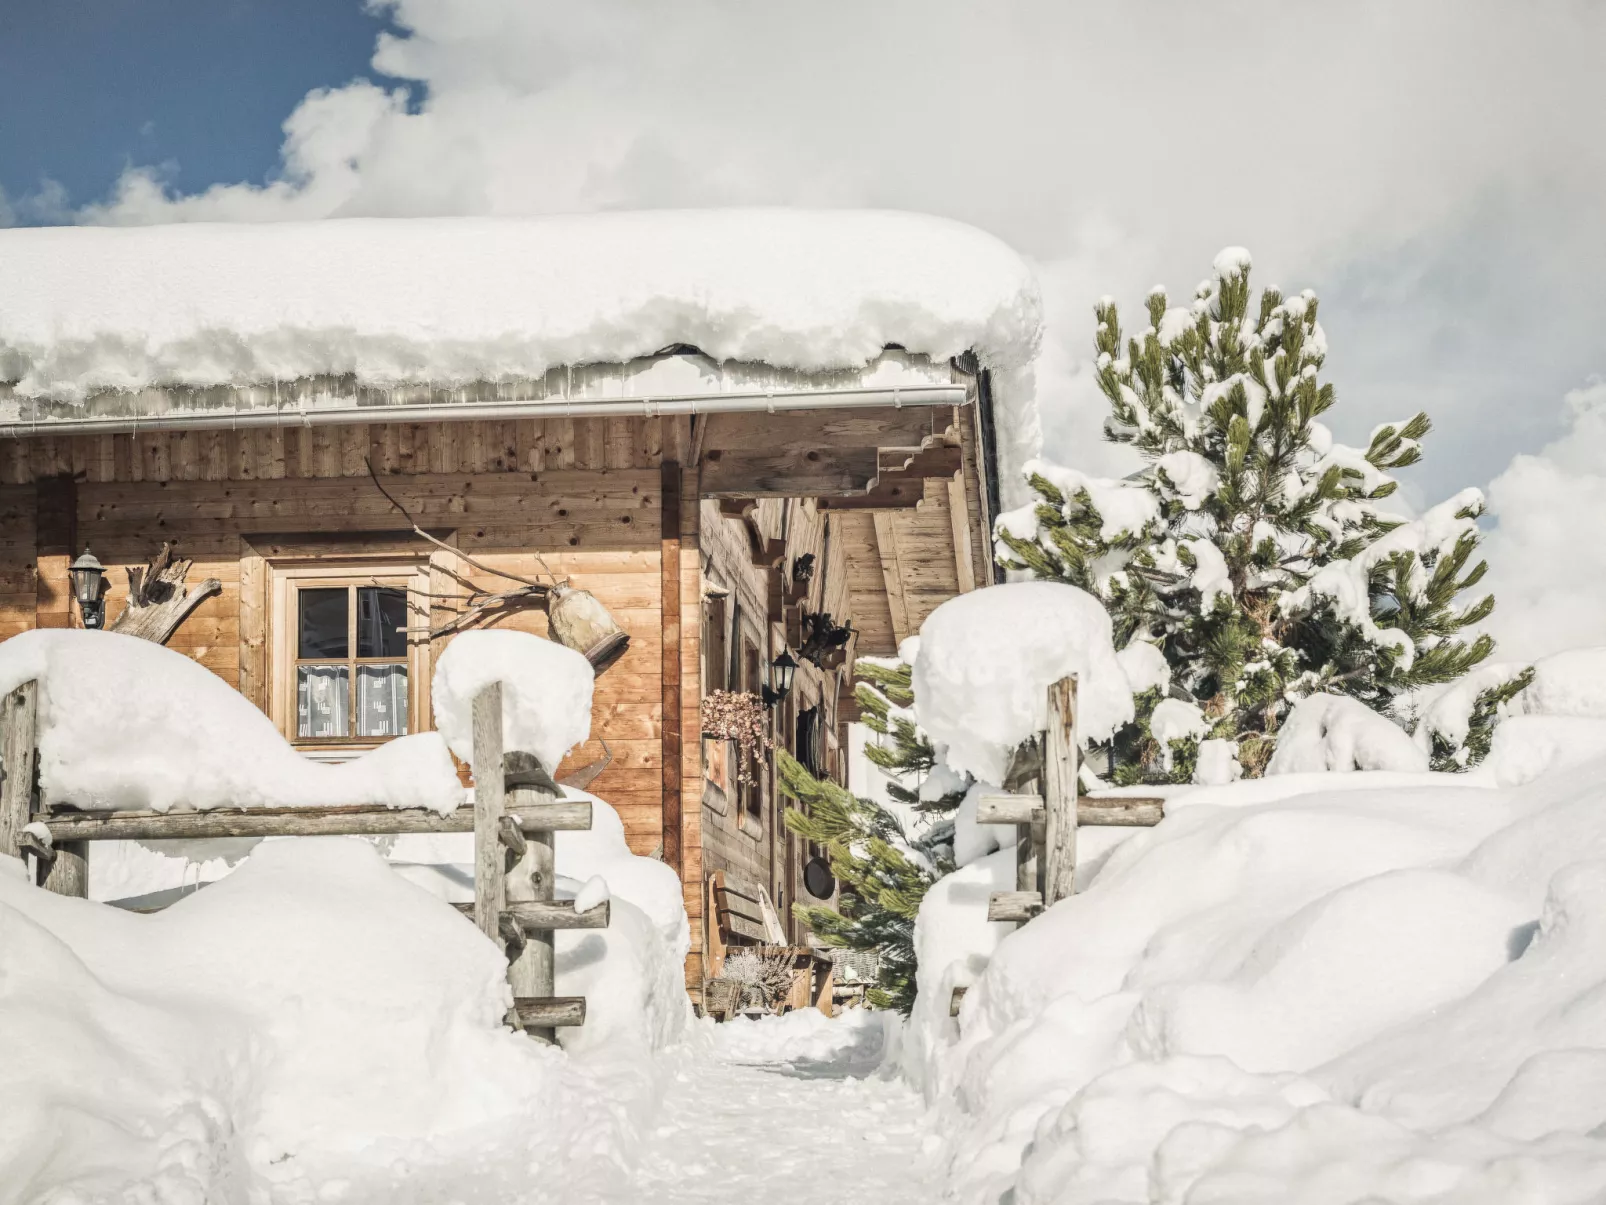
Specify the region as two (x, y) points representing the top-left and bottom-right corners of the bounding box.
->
(430, 631), (596, 771)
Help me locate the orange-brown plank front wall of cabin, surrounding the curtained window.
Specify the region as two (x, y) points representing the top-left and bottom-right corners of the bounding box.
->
(0, 418), (702, 978)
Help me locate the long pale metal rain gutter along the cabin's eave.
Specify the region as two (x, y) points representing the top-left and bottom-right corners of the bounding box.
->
(0, 384), (965, 439)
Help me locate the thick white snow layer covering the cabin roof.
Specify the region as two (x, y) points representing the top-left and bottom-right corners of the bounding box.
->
(0, 209), (1041, 400)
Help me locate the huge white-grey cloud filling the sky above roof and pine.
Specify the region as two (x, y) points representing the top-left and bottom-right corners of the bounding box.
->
(65, 0), (1606, 520)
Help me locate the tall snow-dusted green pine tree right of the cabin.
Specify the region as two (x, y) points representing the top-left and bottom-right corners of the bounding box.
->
(997, 247), (1510, 782)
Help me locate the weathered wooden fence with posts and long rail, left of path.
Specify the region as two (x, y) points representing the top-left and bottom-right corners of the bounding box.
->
(0, 681), (610, 1041)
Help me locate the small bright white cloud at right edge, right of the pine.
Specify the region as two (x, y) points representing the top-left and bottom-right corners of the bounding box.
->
(1484, 379), (1606, 660)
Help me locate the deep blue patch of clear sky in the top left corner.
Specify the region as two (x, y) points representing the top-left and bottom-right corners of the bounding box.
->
(0, 0), (382, 220)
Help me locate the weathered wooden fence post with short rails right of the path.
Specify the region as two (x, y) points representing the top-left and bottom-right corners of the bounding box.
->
(949, 675), (1164, 1017)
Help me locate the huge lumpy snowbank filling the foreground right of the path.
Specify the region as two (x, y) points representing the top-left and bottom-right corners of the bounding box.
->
(904, 755), (1606, 1205)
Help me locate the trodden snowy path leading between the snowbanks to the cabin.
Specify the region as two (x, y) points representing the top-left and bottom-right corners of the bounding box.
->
(607, 1014), (940, 1205)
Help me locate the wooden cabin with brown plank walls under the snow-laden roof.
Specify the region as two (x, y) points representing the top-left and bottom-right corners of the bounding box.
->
(0, 212), (1034, 991)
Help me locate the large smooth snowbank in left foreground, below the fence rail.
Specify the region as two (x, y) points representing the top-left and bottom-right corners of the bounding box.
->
(0, 837), (620, 1202)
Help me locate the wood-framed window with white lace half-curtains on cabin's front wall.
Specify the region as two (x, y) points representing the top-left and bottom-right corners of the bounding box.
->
(270, 564), (429, 752)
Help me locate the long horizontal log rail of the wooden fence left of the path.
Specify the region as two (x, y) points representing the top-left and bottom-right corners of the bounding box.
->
(35, 800), (591, 842)
